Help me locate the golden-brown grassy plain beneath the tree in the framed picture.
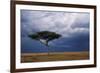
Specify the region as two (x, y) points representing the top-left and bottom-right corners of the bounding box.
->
(21, 51), (89, 63)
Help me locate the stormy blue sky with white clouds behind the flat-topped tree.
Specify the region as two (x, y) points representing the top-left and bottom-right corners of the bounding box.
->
(21, 10), (90, 52)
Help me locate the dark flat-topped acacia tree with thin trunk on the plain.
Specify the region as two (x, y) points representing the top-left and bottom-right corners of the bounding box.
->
(29, 31), (61, 55)
